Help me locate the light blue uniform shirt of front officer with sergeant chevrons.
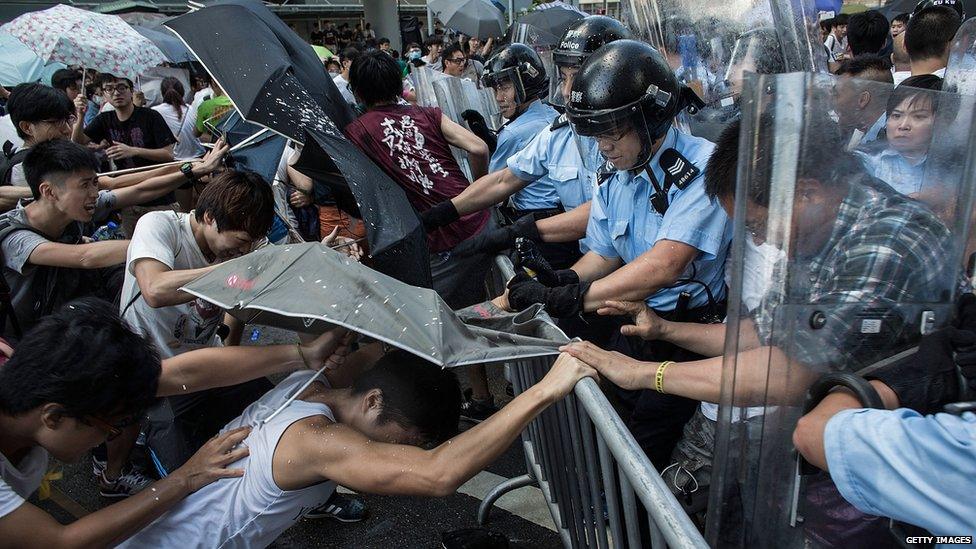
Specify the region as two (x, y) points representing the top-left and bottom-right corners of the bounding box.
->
(586, 128), (732, 311)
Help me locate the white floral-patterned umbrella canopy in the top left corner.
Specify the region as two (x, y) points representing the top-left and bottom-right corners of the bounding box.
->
(0, 4), (166, 78)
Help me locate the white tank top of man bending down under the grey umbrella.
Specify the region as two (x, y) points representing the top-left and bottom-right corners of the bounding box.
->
(119, 370), (336, 549)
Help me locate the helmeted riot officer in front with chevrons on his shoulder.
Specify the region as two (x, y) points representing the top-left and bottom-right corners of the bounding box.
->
(507, 40), (731, 466)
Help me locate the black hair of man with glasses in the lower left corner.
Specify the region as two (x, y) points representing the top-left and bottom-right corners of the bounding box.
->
(0, 297), (161, 418)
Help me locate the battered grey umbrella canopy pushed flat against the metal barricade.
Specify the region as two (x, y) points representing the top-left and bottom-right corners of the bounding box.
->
(182, 242), (566, 366)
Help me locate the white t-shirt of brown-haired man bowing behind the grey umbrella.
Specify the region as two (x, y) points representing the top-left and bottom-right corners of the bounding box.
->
(119, 211), (223, 358)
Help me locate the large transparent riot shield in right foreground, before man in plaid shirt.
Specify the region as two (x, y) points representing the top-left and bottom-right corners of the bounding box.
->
(706, 73), (976, 548)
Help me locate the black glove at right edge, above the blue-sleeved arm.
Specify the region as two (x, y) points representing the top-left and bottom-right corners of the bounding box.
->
(866, 327), (976, 414)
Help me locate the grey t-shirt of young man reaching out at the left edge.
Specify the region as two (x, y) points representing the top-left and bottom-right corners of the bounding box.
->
(0, 191), (116, 337)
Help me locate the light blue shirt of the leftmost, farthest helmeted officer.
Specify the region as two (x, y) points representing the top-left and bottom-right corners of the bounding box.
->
(488, 100), (559, 210)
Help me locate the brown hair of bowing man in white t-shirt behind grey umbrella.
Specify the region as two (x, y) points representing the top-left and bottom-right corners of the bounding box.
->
(194, 170), (274, 235)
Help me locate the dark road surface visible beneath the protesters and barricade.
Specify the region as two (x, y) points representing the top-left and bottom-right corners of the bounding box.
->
(33, 327), (560, 549)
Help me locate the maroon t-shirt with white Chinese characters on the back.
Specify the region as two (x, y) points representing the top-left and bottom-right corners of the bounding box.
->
(346, 105), (491, 252)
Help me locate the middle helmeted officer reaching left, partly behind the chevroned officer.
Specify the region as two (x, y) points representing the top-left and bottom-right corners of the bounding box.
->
(424, 15), (631, 268)
